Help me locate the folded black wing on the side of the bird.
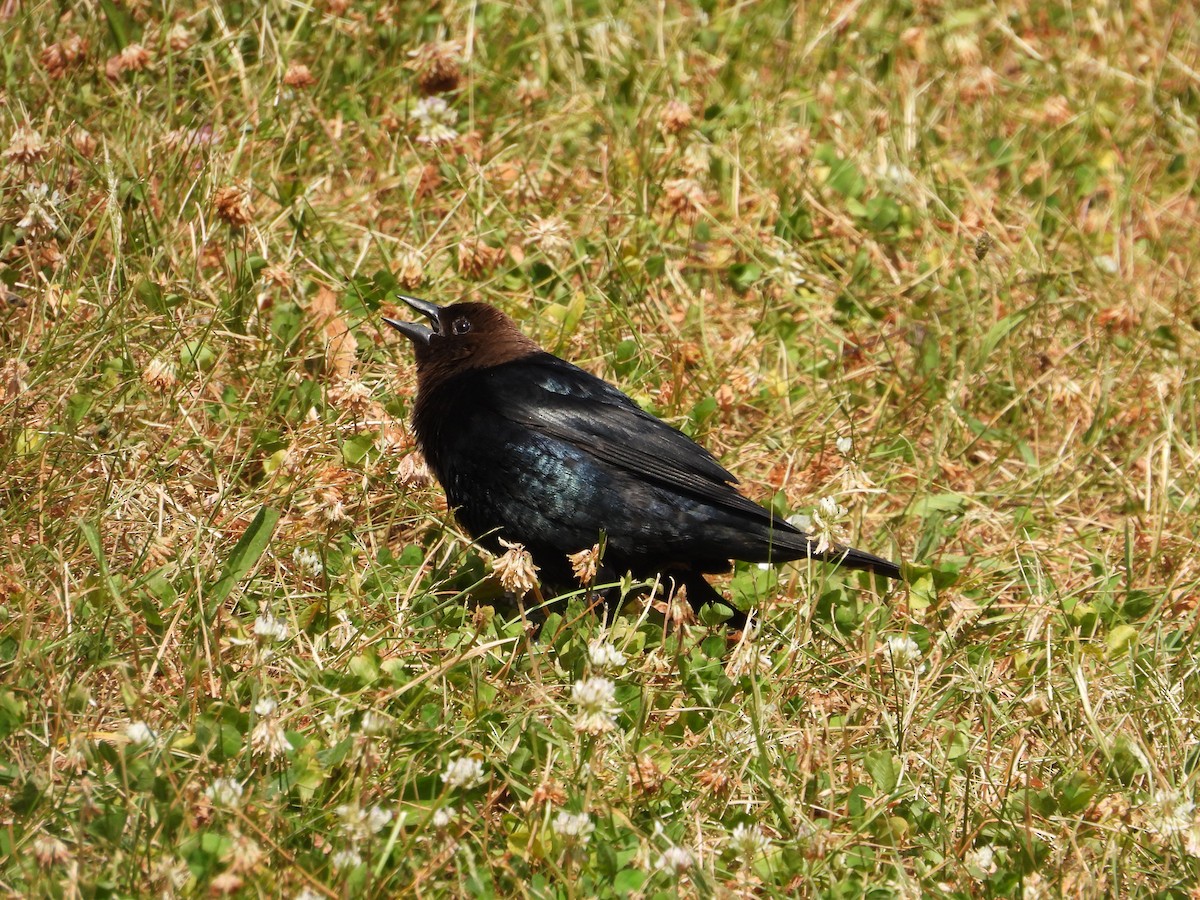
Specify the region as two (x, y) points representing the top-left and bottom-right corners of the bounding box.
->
(488, 354), (770, 518)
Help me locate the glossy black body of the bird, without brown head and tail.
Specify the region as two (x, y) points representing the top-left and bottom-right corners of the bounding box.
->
(414, 353), (830, 571)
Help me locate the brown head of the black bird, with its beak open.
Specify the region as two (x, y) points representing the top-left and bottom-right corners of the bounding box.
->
(384, 294), (541, 391)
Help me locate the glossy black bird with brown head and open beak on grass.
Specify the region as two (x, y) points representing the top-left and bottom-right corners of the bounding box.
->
(384, 296), (900, 628)
